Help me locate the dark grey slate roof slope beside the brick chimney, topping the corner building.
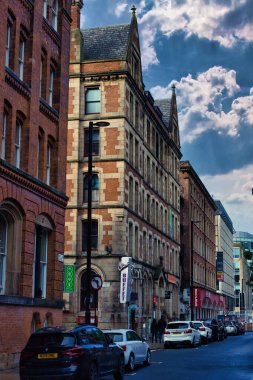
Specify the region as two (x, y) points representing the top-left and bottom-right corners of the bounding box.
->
(81, 24), (131, 61)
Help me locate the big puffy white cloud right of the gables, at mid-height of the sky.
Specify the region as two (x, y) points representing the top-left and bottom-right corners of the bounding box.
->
(151, 66), (253, 143)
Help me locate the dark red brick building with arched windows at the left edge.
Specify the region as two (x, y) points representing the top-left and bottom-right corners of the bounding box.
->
(0, 0), (71, 368)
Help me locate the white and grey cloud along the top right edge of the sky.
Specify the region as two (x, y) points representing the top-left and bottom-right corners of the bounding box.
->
(139, 0), (253, 66)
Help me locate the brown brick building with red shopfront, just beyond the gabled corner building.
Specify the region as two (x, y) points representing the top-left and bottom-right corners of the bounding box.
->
(180, 161), (219, 319)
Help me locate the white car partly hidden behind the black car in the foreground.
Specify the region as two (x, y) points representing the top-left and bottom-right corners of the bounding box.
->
(103, 329), (151, 371)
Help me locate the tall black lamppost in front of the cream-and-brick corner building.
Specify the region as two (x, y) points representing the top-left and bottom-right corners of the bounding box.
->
(85, 121), (110, 324)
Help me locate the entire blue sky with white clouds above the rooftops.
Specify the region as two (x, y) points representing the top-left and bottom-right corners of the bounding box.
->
(82, 0), (253, 233)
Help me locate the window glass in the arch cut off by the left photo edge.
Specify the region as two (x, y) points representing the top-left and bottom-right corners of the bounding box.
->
(0, 214), (7, 294)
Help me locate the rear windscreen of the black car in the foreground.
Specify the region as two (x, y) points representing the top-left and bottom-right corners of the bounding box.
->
(27, 333), (76, 347)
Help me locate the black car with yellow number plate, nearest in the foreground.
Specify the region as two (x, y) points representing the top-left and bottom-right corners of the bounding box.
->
(19, 325), (125, 380)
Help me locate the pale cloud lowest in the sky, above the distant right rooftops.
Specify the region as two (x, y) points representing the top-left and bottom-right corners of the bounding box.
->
(201, 165), (253, 233)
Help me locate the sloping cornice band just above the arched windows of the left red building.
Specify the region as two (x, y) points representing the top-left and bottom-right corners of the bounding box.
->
(0, 159), (68, 208)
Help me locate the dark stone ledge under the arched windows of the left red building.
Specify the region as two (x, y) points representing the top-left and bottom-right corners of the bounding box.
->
(0, 295), (64, 309)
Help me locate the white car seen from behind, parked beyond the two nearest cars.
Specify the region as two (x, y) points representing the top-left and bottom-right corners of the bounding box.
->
(164, 321), (201, 348)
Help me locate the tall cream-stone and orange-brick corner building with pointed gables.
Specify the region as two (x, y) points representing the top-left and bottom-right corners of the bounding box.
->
(65, 1), (181, 334)
